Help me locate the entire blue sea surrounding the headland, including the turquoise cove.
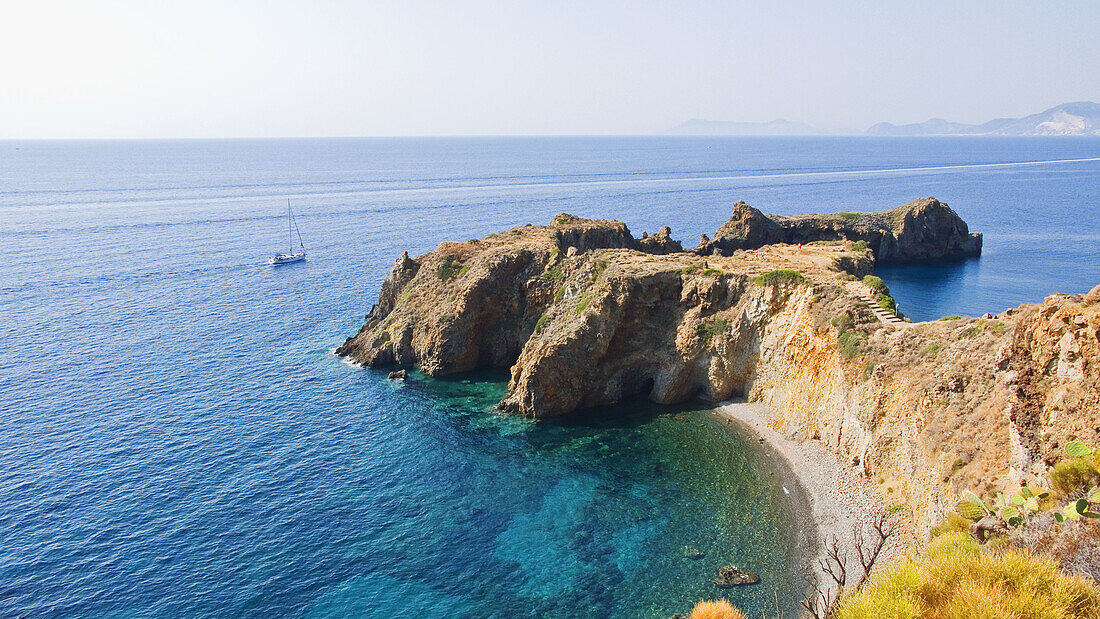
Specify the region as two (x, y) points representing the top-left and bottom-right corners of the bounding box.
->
(0, 136), (1100, 618)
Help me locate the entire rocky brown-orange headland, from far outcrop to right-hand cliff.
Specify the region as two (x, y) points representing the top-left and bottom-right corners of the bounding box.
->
(337, 198), (1100, 547)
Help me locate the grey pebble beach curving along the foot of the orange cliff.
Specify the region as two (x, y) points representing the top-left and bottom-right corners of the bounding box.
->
(715, 401), (881, 602)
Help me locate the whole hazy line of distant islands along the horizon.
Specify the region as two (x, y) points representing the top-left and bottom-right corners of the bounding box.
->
(668, 101), (1100, 136)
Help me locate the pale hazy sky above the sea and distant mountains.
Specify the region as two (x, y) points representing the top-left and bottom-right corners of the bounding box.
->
(0, 0), (1100, 137)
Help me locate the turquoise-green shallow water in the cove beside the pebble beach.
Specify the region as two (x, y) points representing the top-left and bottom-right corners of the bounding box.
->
(306, 375), (798, 617)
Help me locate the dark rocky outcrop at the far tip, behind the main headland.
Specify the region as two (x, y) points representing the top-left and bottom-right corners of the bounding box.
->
(696, 198), (981, 262)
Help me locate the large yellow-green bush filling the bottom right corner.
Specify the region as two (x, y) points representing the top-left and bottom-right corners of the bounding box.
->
(837, 532), (1100, 619)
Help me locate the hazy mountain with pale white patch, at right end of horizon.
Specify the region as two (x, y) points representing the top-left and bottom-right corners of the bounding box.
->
(867, 101), (1100, 135)
